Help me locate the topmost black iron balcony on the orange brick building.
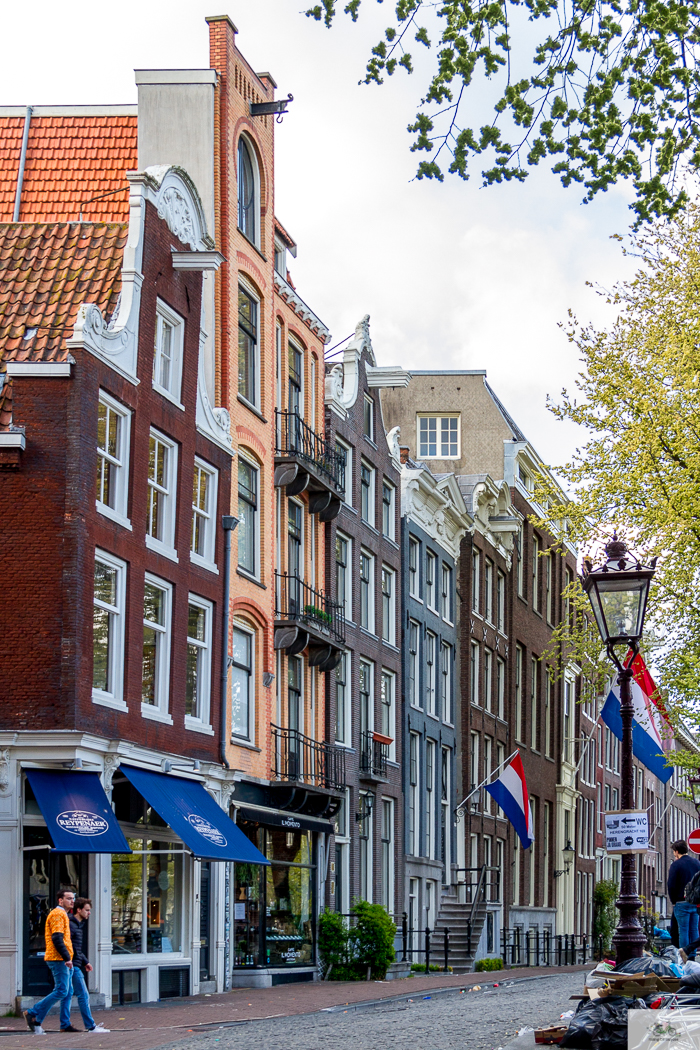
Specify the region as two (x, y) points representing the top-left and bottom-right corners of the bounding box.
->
(275, 408), (345, 522)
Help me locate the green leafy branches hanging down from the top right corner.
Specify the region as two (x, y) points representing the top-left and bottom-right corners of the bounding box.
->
(305, 0), (700, 221)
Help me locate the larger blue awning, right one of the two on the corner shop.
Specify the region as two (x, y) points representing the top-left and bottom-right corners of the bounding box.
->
(120, 765), (270, 864)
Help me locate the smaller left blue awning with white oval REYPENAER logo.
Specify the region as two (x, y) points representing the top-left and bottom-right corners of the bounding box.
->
(26, 770), (131, 853)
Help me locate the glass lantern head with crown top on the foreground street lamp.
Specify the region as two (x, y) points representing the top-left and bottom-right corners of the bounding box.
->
(582, 540), (654, 646)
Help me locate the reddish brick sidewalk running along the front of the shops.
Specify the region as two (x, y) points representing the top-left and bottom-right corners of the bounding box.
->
(0, 964), (591, 1050)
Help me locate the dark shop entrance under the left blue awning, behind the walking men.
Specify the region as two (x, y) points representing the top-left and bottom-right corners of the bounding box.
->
(22, 827), (89, 995)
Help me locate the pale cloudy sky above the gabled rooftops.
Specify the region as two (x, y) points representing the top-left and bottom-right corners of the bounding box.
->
(0, 0), (631, 464)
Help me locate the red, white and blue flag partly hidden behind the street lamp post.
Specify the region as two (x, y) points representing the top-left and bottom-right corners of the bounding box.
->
(600, 652), (673, 783)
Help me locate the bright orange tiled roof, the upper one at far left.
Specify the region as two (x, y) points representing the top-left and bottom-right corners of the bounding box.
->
(0, 111), (137, 223)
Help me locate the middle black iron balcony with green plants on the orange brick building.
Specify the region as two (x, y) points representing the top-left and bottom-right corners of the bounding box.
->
(275, 572), (345, 671)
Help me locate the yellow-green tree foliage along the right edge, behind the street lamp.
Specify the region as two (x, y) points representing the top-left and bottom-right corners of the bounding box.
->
(537, 204), (700, 739)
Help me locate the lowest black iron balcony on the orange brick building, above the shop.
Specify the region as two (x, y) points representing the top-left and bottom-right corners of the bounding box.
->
(270, 726), (345, 817)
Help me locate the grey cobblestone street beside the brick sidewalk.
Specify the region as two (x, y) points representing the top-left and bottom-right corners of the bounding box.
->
(161, 973), (582, 1050)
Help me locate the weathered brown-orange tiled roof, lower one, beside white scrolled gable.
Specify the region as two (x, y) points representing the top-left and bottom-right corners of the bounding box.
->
(0, 223), (128, 369)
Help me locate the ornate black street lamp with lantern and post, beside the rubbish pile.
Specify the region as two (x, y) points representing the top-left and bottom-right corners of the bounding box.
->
(581, 534), (656, 962)
